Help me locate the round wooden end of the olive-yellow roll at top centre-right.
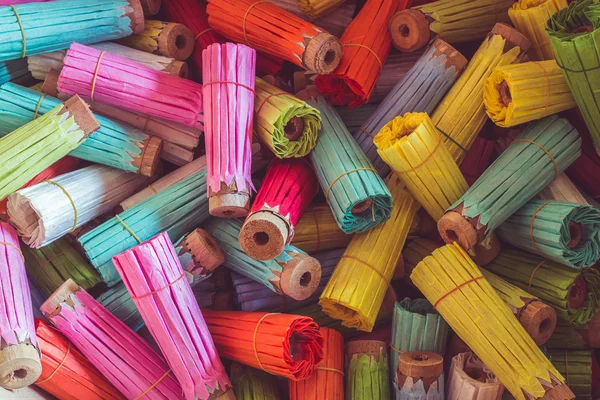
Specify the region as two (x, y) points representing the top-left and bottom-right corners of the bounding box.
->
(390, 9), (432, 53)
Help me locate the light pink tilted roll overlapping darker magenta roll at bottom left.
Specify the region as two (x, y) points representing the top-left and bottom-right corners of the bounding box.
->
(113, 232), (231, 400)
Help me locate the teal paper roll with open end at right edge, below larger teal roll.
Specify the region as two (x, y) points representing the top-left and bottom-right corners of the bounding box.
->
(497, 200), (600, 268)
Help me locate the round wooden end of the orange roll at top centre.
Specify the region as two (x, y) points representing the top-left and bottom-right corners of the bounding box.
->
(302, 32), (343, 75)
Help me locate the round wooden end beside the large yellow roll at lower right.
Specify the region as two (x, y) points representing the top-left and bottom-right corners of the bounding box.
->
(517, 300), (556, 346)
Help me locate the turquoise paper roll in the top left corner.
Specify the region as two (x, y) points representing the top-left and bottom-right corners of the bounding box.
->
(0, 0), (144, 61)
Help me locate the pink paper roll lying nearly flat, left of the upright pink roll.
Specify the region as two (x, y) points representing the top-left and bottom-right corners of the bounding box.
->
(58, 43), (203, 129)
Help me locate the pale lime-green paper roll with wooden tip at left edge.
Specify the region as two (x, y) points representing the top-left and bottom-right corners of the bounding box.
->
(0, 96), (100, 200)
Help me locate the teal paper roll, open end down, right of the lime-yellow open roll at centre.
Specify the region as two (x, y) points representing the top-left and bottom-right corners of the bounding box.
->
(308, 97), (392, 233)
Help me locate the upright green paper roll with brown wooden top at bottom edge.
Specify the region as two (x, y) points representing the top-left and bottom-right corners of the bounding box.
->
(345, 340), (390, 400)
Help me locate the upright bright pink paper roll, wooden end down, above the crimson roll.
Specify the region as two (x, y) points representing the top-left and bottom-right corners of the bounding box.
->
(202, 43), (256, 218)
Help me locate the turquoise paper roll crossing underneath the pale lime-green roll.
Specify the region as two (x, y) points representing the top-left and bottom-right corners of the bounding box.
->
(0, 83), (161, 176)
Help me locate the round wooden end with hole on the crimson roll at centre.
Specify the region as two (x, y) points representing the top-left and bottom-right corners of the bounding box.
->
(239, 211), (290, 261)
